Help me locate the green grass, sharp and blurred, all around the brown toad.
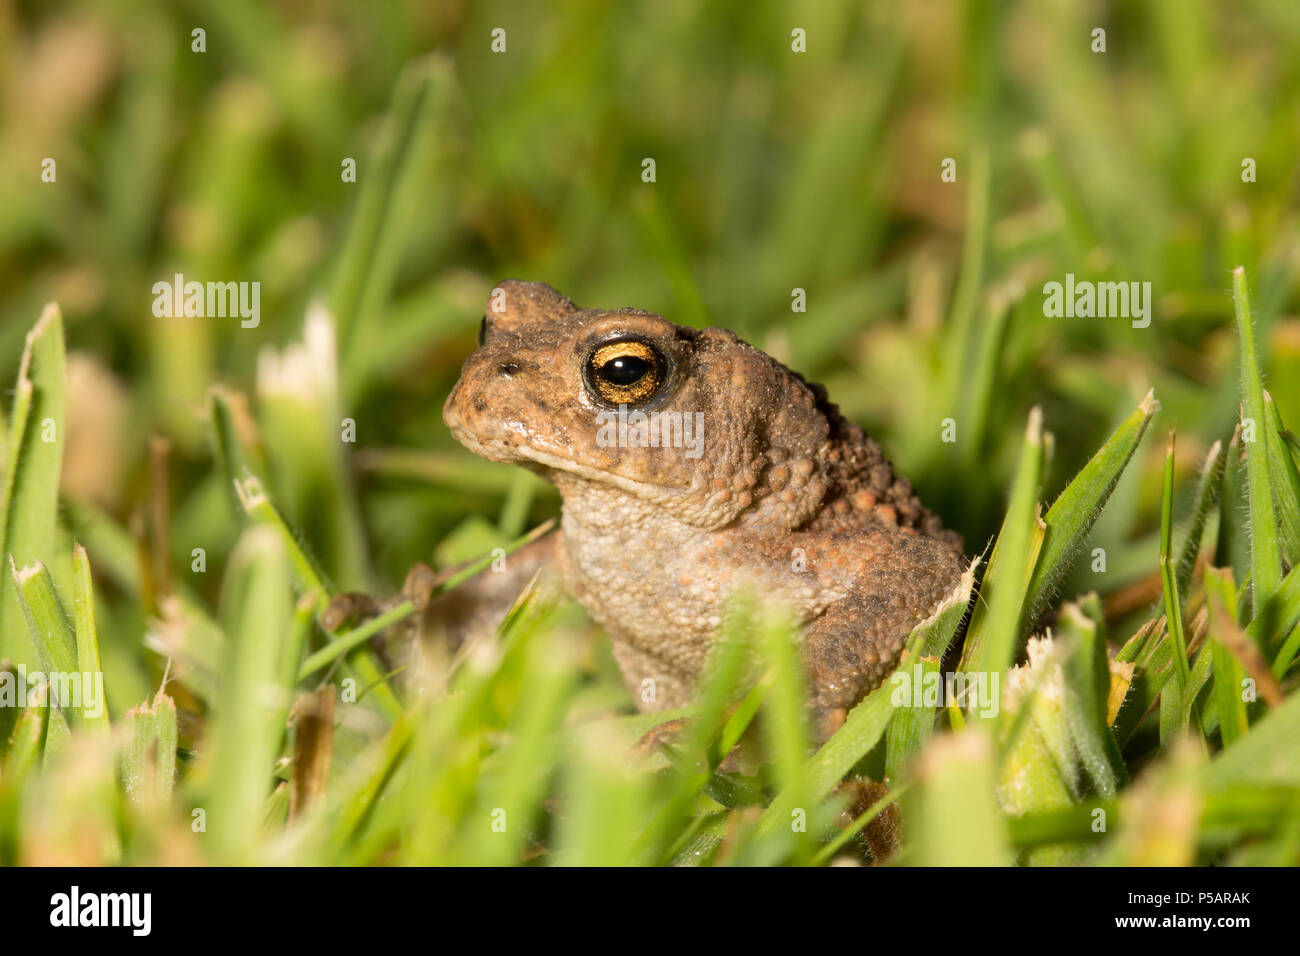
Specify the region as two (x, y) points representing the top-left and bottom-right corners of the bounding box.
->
(0, 0), (1300, 865)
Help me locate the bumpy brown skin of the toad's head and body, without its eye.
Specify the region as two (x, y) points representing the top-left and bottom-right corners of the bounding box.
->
(443, 280), (963, 736)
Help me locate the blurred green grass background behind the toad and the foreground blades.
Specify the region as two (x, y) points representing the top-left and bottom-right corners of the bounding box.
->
(0, 0), (1300, 868)
